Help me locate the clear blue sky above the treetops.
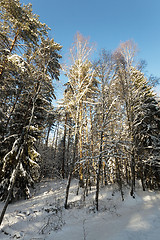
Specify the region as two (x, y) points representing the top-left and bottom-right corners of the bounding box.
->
(20, 0), (160, 96)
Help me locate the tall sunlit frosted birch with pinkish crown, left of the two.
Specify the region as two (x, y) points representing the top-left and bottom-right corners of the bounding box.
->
(63, 33), (97, 208)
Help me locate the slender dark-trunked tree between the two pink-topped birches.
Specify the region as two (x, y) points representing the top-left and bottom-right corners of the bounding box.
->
(95, 50), (118, 210)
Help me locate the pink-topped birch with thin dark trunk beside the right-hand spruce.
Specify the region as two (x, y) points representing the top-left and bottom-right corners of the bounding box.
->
(114, 41), (136, 197)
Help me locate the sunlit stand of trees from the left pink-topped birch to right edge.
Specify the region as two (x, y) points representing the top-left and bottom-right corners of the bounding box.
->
(59, 33), (160, 210)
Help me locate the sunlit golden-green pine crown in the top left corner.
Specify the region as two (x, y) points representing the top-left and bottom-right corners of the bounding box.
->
(0, 0), (49, 77)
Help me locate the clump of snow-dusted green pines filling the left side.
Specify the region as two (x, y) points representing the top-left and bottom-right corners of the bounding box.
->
(0, 0), (61, 225)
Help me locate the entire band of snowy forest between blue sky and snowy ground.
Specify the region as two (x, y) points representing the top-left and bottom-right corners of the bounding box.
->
(0, 0), (160, 220)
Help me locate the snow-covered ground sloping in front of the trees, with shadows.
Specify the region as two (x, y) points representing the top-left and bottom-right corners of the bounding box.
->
(0, 180), (160, 240)
